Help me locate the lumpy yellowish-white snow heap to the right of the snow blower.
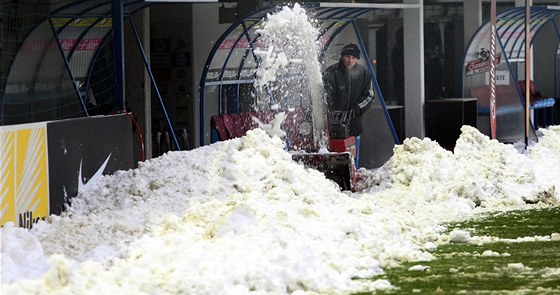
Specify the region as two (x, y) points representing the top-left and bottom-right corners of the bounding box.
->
(358, 126), (560, 208)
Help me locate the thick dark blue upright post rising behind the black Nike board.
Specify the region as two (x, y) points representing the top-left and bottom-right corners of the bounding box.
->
(111, 0), (126, 111)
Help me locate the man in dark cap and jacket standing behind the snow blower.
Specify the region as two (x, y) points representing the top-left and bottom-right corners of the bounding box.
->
(323, 43), (375, 169)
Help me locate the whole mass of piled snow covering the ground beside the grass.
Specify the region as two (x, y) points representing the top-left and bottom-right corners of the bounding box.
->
(0, 2), (560, 295)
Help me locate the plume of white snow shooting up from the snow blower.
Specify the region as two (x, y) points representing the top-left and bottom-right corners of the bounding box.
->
(254, 3), (326, 149)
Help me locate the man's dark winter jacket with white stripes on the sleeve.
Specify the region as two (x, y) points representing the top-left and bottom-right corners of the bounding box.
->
(323, 60), (375, 136)
